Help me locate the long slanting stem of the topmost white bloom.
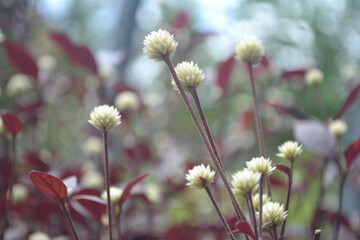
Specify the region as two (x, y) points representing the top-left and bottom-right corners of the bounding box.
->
(163, 54), (247, 224)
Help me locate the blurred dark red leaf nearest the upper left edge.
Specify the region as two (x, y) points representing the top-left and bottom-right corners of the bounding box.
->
(4, 41), (39, 80)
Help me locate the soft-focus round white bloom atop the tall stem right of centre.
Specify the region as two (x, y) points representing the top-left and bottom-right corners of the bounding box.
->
(235, 36), (265, 64)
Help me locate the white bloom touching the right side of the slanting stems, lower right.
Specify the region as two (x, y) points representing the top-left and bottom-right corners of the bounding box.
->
(231, 169), (260, 196)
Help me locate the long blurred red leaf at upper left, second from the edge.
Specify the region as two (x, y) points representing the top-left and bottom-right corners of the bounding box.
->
(50, 31), (98, 75)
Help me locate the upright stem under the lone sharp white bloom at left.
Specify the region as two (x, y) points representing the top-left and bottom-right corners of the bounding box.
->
(103, 130), (113, 240)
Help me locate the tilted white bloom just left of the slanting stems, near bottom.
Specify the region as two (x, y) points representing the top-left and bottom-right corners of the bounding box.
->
(185, 164), (215, 189)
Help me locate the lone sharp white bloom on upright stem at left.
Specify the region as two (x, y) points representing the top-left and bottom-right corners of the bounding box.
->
(89, 105), (121, 131)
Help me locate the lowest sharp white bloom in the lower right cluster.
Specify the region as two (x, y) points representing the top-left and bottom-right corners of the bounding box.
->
(262, 202), (287, 228)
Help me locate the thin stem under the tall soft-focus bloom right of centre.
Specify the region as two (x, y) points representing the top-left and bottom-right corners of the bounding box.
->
(247, 63), (272, 199)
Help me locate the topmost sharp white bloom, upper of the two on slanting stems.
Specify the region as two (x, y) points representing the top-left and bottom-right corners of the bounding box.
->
(143, 29), (178, 62)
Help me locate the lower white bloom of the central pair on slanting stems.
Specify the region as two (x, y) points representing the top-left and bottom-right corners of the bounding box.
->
(171, 61), (205, 92)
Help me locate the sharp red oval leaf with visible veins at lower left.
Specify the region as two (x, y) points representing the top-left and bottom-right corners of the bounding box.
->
(29, 171), (67, 203)
